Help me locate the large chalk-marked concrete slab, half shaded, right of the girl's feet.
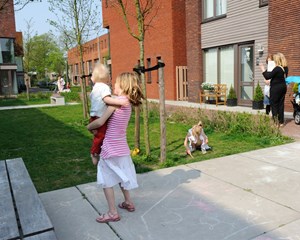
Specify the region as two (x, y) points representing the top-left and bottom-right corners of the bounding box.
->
(78, 166), (300, 240)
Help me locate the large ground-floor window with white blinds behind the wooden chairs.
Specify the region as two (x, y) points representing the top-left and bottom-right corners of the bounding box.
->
(204, 46), (234, 89)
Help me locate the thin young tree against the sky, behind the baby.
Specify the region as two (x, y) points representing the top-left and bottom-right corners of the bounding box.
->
(48, 0), (101, 118)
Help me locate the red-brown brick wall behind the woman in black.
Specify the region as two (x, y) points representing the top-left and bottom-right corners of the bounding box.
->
(269, 0), (300, 111)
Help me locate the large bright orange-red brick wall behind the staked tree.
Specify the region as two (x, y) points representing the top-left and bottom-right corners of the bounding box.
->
(103, 0), (186, 100)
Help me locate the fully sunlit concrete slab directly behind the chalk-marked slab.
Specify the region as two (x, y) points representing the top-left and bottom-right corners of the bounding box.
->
(188, 146), (300, 211)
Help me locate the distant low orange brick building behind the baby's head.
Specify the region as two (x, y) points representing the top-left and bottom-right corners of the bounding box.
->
(68, 34), (110, 85)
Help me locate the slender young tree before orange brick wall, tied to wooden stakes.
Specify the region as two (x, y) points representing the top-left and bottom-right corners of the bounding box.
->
(109, 0), (159, 155)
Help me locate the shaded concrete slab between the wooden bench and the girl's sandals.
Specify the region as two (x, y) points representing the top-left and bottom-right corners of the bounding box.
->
(39, 187), (119, 240)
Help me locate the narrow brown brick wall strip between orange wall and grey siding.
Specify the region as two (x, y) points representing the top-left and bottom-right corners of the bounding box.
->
(185, 0), (203, 102)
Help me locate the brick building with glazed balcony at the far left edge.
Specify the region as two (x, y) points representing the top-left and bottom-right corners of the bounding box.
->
(0, 0), (24, 97)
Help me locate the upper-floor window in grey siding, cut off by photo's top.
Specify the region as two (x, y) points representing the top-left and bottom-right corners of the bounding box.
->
(203, 0), (227, 20)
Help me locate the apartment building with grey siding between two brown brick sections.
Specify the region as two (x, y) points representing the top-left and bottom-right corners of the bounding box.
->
(186, 0), (300, 110)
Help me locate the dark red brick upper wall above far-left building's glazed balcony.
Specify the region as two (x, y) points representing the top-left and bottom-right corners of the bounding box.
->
(0, 0), (16, 38)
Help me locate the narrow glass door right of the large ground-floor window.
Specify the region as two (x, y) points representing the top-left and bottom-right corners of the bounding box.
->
(238, 44), (254, 106)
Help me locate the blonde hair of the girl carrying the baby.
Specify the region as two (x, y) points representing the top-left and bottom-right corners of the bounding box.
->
(116, 72), (144, 106)
